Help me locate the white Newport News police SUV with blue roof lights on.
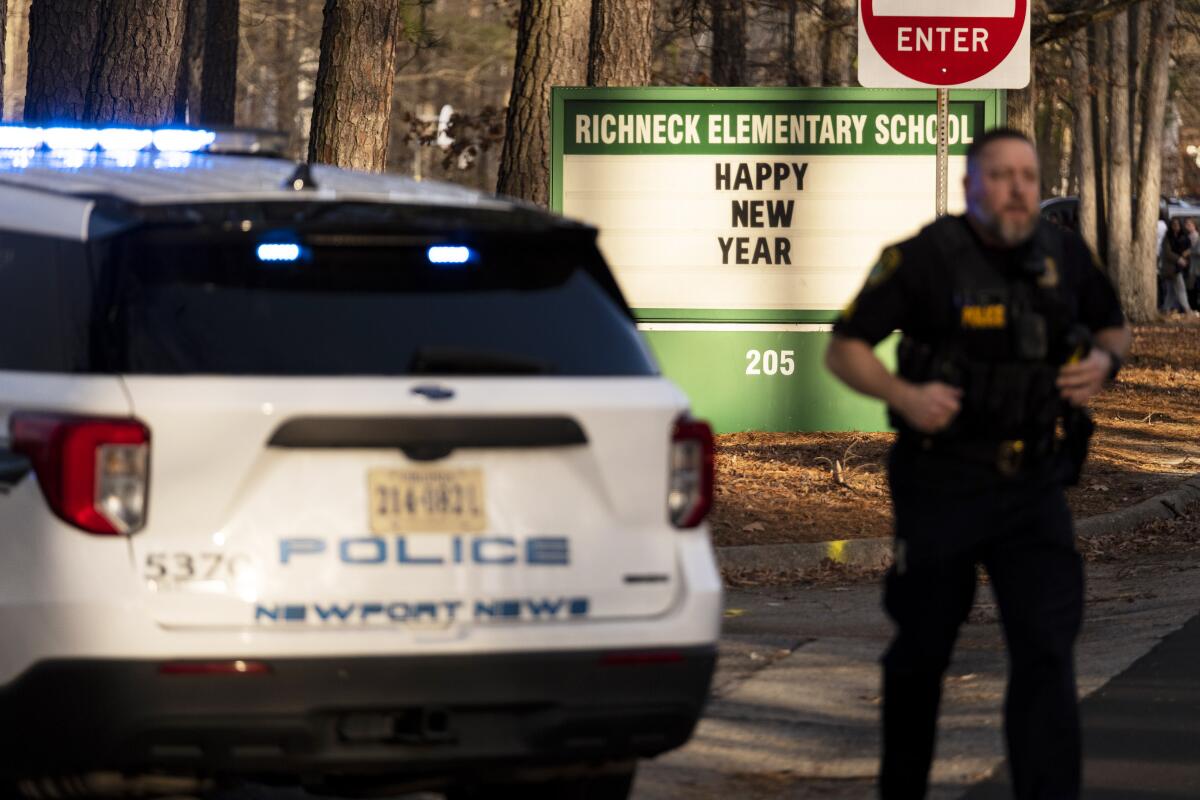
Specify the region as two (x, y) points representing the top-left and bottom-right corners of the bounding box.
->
(0, 127), (721, 798)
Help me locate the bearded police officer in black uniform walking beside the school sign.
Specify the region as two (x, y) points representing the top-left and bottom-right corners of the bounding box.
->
(827, 128), (1130, 800)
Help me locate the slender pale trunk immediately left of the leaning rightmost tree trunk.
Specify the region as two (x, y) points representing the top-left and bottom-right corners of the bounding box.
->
(1108, 14), (1140, 303)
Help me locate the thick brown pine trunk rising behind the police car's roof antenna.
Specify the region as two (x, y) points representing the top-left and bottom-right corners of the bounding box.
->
(308, 0), (403, 172)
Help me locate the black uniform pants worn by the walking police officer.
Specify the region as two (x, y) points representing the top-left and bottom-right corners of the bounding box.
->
(880, 475), (1084, 800)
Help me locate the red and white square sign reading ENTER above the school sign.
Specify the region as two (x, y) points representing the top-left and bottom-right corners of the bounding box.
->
(858, 0), (1031, 89)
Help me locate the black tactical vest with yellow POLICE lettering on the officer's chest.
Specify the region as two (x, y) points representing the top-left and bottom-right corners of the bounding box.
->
(892, 217), (1087, 456)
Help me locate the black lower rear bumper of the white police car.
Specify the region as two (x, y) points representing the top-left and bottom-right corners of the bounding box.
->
(0, 646), (715, 778)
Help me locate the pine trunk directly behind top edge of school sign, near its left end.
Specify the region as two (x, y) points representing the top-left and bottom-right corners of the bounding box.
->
(588, 0), (654, 86)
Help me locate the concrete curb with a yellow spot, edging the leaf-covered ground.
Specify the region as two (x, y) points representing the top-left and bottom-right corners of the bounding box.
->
(716, 475), (1200, 571)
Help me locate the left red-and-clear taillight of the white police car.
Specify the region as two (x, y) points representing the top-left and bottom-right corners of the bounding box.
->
(8, 413), (150, 535)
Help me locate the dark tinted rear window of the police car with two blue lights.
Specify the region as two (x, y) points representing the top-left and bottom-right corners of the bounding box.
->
(95, 227), (656, 375)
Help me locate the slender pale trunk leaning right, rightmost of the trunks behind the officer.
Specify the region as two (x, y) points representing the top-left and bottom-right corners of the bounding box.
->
(1121, 0), (1175, 323)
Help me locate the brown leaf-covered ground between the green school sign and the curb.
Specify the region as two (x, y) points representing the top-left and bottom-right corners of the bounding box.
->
(712, 320), (1200, 547)
